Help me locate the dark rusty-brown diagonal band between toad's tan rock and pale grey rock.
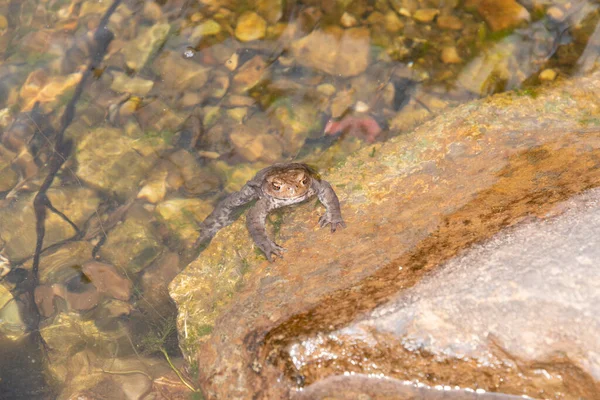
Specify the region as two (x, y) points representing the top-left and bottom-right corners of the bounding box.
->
(259, 131), (600, 393)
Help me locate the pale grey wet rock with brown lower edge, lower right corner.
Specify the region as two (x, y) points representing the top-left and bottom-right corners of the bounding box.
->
(288, 189), (600, 399)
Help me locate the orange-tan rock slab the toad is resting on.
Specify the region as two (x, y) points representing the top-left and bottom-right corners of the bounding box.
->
(170, 75), (600, 398)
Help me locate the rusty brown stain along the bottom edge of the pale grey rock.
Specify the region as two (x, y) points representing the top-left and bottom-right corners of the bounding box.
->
(291, 332), (600, 400)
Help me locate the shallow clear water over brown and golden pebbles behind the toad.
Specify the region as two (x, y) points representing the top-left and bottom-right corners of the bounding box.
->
(0, 0), (598, 398)
